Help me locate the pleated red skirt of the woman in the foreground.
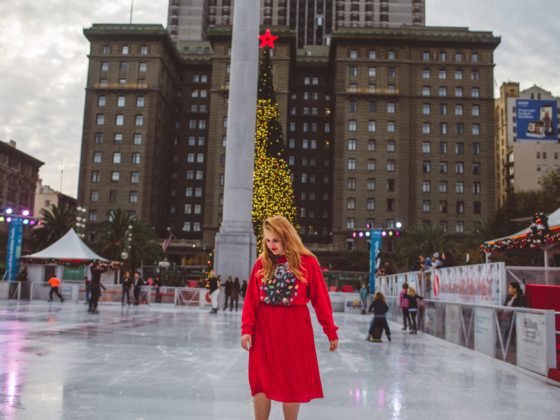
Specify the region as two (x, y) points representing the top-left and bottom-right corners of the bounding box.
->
(249, 304), (323, 403)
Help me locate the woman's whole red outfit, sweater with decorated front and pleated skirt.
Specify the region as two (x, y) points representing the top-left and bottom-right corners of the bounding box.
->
(241, 255), (338, 403)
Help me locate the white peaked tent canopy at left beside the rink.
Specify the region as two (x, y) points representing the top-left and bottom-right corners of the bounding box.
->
(21, 229), (108, 263)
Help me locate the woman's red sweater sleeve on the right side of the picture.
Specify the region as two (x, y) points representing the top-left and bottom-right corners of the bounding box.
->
(306, 257), (338, 340)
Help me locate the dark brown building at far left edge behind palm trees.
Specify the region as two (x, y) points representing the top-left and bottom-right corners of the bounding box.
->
(0, 140), (44, 214)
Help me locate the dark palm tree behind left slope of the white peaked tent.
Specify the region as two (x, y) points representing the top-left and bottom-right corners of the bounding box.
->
(31, 204), (76, 251)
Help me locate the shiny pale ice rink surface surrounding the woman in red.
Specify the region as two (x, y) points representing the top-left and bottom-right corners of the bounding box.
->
(0, 302), (560, 420)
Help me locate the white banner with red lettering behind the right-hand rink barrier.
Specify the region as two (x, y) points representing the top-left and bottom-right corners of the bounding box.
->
(431, 262), (506, 305)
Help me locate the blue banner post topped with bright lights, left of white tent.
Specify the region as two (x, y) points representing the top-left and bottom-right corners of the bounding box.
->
(0, 208), (37, 281)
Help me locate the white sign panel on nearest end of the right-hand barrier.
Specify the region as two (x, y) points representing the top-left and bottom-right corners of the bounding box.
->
(515, 311), (556, 376)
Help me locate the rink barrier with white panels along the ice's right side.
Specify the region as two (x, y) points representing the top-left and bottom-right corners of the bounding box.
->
(387, 296), (557, 377)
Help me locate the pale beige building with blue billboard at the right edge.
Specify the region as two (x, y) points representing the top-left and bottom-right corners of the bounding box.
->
(495, 82), (560, 206)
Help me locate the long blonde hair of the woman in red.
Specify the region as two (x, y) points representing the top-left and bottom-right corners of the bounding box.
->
(257, 216), (315, 283)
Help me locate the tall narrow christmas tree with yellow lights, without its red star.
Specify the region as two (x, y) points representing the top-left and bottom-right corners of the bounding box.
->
(253, 48), (297, 251)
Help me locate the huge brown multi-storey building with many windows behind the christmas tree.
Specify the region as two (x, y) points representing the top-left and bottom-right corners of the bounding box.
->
(78, 25), (499, 260)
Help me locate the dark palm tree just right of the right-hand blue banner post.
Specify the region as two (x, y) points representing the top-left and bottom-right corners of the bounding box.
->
(396, 224), (448, 269)
